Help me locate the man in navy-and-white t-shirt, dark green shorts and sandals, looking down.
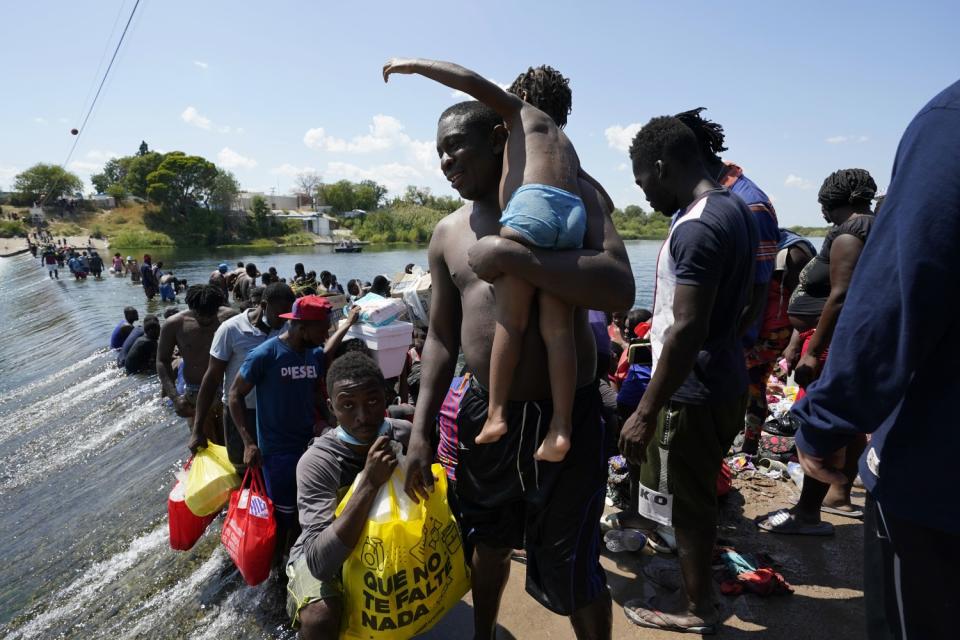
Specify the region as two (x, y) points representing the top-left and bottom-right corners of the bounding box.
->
(620, 117), (758, 633)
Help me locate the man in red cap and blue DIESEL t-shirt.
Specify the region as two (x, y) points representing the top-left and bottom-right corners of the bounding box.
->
(229, 296), (359, 575)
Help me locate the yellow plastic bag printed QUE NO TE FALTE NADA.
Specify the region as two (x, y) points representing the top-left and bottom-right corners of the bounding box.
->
(337, 464), (470, 640)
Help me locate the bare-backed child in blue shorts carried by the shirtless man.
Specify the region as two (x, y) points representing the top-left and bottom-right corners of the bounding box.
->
(383, 59), (587, 462)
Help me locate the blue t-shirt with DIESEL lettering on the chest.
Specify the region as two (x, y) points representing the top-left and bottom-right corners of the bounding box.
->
(238, 336), (324, 455)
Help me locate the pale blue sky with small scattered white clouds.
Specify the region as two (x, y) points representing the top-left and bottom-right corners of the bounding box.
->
(0, 0), (960, 225)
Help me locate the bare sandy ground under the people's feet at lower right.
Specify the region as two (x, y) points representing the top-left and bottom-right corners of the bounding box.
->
(423, 479), (865, 640)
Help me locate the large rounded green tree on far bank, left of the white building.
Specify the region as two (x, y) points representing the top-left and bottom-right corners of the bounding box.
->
(143, 153), (218, 218)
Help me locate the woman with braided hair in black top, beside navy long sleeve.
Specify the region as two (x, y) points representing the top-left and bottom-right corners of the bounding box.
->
(758, 169), (877, 535)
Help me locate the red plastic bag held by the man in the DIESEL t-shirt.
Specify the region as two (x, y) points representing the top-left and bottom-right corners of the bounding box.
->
(220, 469), (277, 586)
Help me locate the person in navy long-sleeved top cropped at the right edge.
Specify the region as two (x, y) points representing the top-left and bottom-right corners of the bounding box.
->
(794, 82), (960, 638)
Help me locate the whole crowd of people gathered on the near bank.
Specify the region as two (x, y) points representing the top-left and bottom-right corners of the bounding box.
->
(86, 59), (960, 638)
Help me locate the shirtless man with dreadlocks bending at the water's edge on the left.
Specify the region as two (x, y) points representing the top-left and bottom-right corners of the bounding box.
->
(157, 284), (237, 444)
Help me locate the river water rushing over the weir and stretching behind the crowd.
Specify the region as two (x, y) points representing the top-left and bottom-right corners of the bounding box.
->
(0, 241), (660, 639)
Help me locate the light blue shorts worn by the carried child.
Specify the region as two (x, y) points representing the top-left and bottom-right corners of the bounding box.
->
(500, 184), (587, 249)
